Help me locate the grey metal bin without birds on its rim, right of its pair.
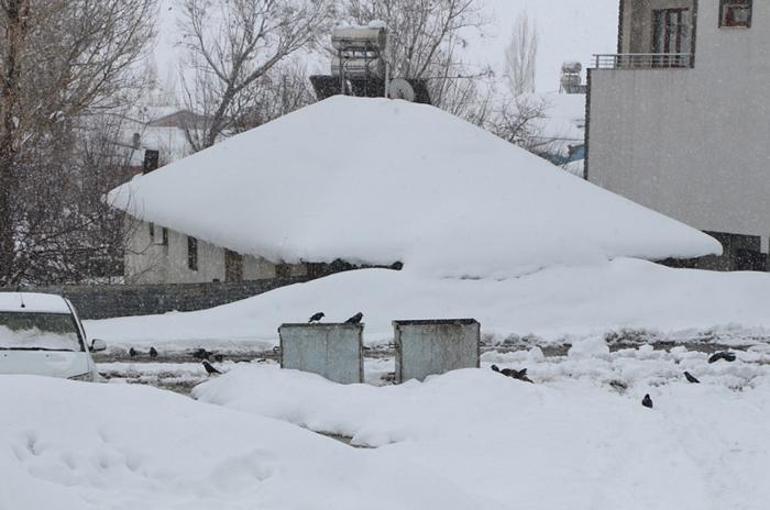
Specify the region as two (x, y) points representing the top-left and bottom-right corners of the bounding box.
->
(393, 319), (481, 383)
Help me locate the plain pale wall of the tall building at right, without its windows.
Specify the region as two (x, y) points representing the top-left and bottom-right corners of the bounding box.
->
(588, 0), (770, 251)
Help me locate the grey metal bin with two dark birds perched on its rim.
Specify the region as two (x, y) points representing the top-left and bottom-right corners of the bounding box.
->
(278, 324), (364, 384)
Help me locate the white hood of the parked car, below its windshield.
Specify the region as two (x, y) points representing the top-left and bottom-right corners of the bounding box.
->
(0, 351), (91, 377)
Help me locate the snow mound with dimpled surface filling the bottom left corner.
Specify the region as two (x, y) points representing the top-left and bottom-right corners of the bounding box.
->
(0, 376), (493, 510)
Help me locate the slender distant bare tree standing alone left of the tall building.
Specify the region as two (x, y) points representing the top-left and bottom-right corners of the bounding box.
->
(505, 11), (538, 97)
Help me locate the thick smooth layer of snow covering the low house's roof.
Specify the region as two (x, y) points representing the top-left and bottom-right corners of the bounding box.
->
(110, 97), (721, 277)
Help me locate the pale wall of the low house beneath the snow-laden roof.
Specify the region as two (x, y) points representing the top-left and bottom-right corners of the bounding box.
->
(125, 220), (307, 284)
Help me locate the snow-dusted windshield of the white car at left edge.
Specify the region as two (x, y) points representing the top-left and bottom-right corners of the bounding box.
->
(0, 312), (82, 351)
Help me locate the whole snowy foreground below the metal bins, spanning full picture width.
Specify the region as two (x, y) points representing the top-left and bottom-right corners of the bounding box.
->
(7, 338), (770, 510)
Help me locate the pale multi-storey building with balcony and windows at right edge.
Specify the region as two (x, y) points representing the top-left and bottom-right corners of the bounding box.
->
(586, 0), (770, 269)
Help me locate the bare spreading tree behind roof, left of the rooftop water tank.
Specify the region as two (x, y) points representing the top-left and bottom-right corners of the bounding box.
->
(182, 0), (334, 150)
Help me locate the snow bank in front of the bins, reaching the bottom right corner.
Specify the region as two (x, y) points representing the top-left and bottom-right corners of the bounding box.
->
(195, 366), (770, 510)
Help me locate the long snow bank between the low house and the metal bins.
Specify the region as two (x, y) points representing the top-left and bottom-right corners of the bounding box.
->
(85, 259), (770, 349)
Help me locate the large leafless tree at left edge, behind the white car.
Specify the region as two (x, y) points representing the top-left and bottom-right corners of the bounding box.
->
(0, 0), (155, 286)
